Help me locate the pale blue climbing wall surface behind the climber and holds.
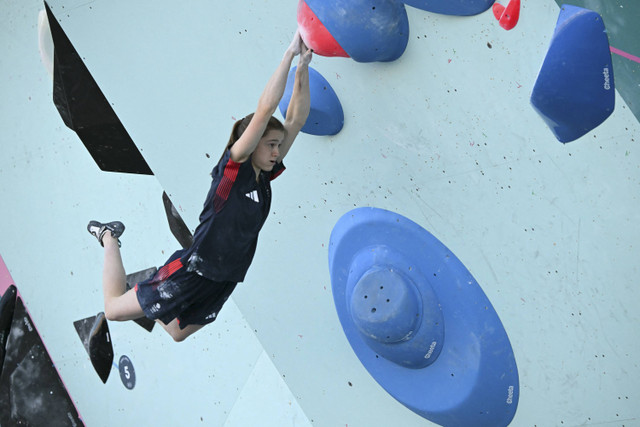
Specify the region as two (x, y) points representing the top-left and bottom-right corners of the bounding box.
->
(0, 0), (640, 427)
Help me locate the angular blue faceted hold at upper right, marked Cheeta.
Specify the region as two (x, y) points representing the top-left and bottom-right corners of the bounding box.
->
(531, 5), (615, 143)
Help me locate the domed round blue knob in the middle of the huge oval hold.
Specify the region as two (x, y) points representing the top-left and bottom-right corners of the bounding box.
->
(345, 245), (445, 369)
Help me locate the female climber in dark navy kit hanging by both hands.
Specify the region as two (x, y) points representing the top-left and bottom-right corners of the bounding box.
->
(87, 32), (312, 341)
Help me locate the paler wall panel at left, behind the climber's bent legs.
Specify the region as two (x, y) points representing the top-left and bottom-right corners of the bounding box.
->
(0, 1), (278, 426)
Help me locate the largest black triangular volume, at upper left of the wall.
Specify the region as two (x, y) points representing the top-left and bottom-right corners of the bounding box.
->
(44, 2), (153, 175)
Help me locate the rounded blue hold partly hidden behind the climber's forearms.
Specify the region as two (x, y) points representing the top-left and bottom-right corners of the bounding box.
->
(279, 67), (344, 135)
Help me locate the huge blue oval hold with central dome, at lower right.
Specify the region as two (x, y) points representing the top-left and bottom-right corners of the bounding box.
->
(329, 208), (520, 427)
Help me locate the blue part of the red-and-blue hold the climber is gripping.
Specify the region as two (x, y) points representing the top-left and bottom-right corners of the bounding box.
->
(305, 0), (409, 62)
